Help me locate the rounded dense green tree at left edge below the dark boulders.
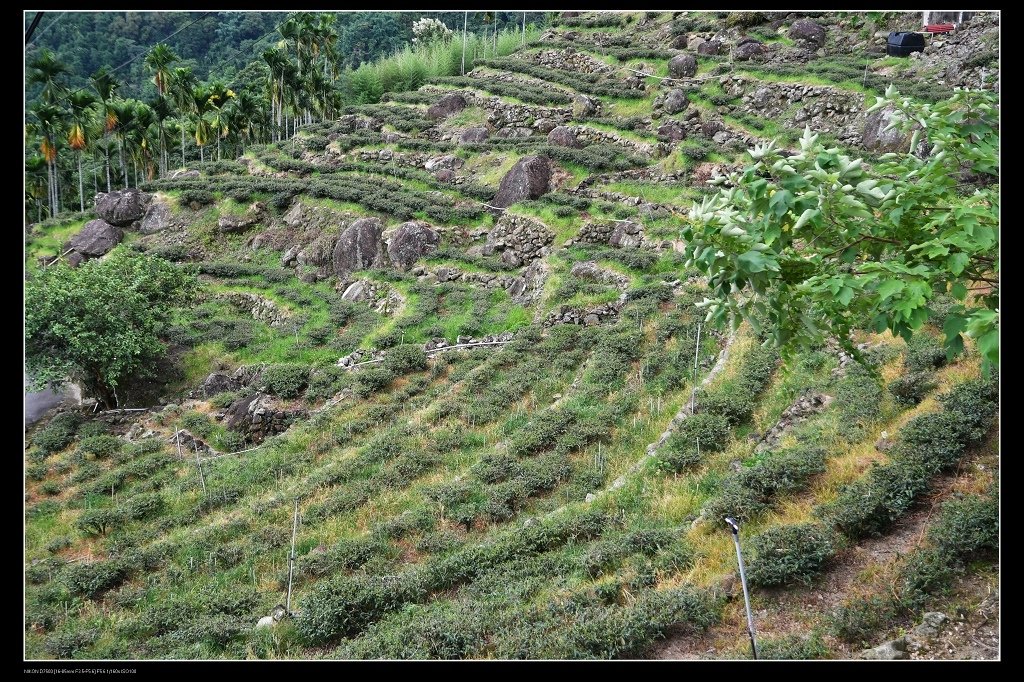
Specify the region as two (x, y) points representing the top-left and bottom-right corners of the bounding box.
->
(25, 247), (198, 407)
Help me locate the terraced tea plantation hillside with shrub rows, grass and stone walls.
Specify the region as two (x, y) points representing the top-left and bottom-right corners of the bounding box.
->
(25, 12), (999, 659)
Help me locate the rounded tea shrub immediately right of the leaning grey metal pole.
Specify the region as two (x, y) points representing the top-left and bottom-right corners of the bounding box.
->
(746, 523), (840, 587)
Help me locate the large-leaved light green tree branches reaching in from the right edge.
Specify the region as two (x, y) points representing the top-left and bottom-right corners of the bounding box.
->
(682, 87), (999, 372)
